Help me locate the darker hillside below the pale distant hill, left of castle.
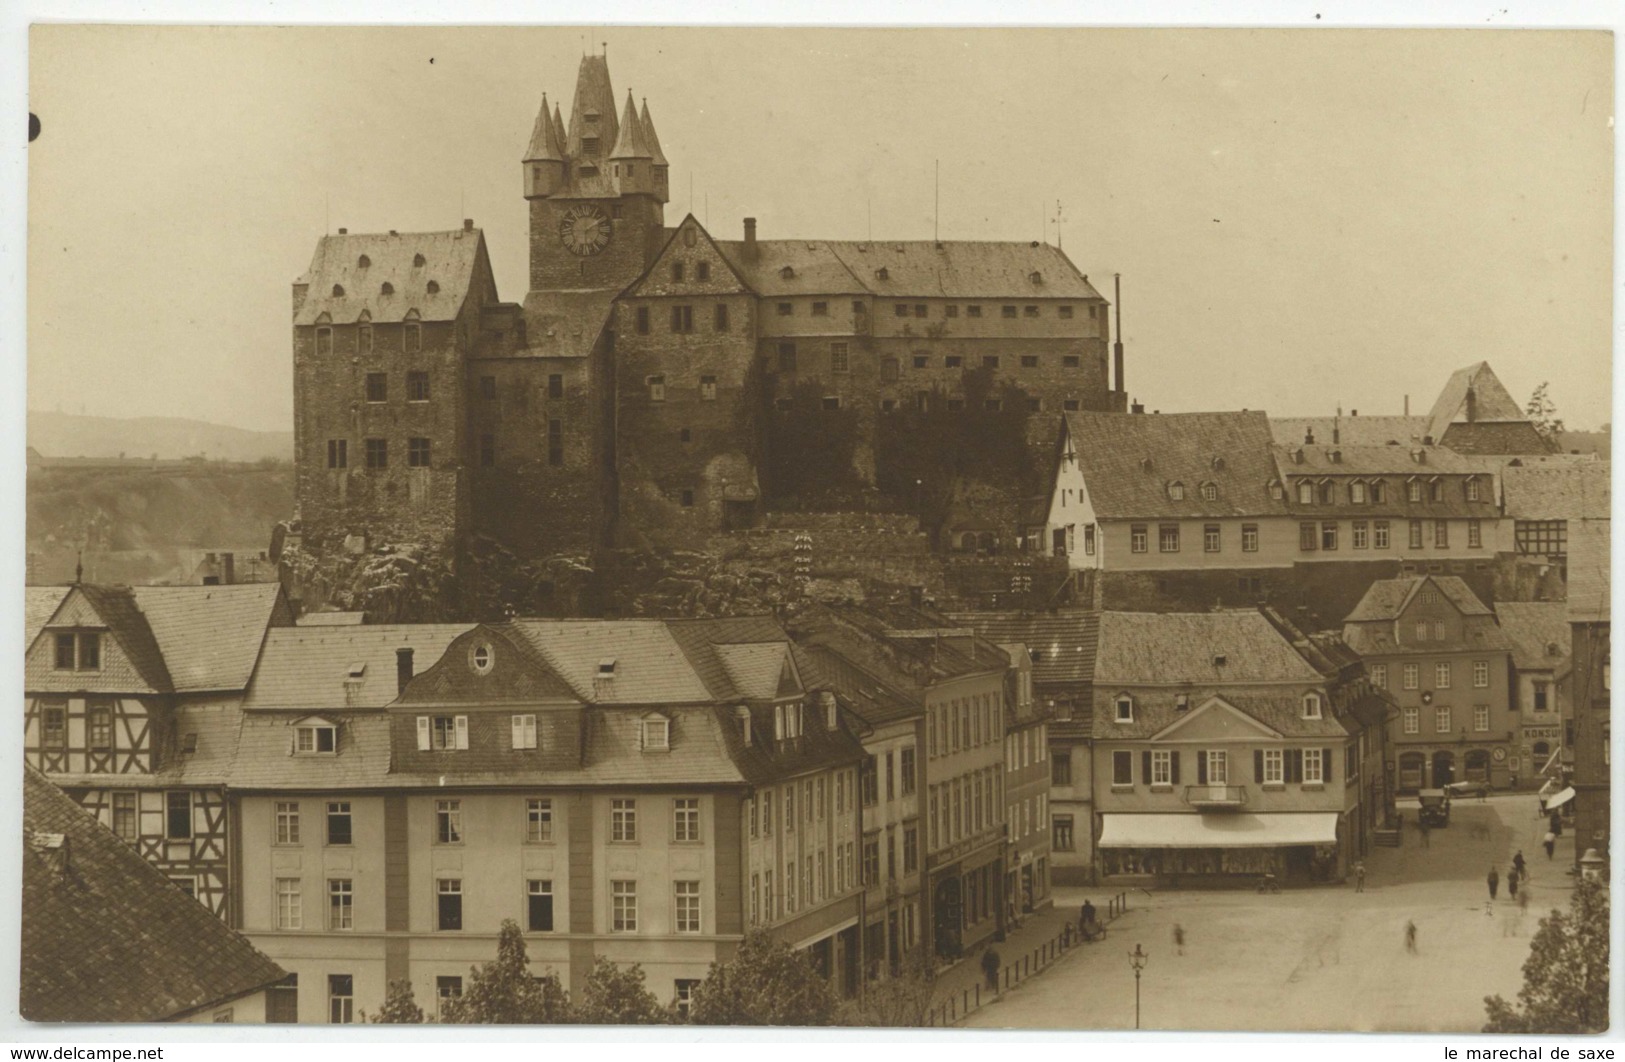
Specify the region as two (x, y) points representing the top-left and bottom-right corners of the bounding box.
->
(28, 464), (294, 583)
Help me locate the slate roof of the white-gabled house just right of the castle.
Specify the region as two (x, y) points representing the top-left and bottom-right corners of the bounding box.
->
(1066, 412), (1287, 520)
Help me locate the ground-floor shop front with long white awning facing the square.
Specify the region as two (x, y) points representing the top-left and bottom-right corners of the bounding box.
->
(1097, 812), (1344, 887)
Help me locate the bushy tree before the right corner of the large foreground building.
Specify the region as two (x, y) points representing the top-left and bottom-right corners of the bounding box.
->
(691, 930), (835, 1025)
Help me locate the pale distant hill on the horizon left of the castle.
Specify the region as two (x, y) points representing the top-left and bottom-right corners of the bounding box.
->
(28, 409), (294, 461)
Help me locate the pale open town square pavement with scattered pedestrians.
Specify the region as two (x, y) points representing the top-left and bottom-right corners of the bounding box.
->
(964, 796), (1573, 1033)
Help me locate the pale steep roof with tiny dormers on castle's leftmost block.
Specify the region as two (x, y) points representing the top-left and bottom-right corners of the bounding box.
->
(294, 229), (496, 325)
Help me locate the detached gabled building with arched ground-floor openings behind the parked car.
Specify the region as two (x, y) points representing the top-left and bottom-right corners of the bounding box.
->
(1344, 575), (1519, 792)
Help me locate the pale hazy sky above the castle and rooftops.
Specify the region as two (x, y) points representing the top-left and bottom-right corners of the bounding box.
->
(28, 26), (1614, 429)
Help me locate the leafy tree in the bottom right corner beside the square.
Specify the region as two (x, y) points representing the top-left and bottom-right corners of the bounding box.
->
(1484, 880), (1609, 1033)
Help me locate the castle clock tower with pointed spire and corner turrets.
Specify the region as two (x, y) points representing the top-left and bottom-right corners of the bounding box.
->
(523, 55), (670, 291)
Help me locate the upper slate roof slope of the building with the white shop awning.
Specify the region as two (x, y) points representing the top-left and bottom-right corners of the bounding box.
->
(1095, 609), (1323, 690)
